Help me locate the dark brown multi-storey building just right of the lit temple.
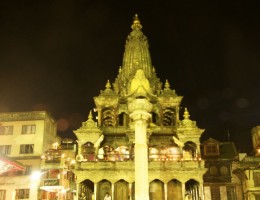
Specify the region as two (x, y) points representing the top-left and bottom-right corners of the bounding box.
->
(201, 138), (243, 200)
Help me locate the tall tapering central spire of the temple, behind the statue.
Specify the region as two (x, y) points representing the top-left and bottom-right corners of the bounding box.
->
(113, 14), (162, 96)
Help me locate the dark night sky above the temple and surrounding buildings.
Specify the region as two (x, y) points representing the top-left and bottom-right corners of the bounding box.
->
(0, 0), (260, 152)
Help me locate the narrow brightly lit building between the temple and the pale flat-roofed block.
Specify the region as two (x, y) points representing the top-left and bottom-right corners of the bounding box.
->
(38, 138), (76, 200)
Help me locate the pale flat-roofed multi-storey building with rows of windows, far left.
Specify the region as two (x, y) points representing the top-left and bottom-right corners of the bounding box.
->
(0, 111), (57, 200)
